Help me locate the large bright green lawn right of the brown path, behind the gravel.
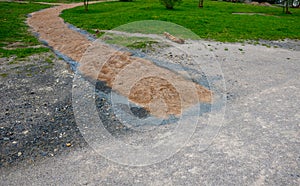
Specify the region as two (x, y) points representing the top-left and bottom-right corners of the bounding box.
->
(61, 0), (300, 42)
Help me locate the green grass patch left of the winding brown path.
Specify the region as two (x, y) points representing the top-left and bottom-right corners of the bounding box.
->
(0, 2), (50, 58)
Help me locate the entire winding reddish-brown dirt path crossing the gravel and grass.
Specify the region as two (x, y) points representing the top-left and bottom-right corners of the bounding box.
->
(27, 3), (212, 117)
